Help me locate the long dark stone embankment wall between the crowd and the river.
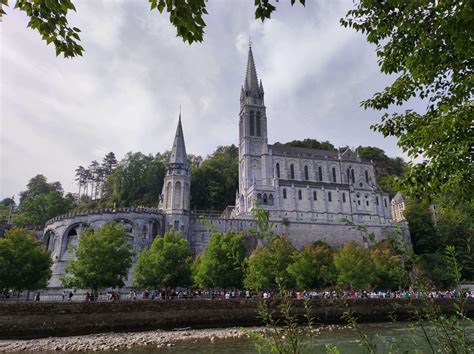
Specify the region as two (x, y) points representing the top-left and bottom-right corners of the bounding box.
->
(0, 299), (474, 339)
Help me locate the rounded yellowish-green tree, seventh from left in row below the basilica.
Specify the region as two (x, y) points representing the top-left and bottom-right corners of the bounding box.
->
(334, 242), (375, 289)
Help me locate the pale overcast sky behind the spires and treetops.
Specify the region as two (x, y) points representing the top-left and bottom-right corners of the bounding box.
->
(0, 0), (422, 198)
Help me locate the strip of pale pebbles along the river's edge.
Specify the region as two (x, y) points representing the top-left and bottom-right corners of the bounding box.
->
(0, 325), (344, 352)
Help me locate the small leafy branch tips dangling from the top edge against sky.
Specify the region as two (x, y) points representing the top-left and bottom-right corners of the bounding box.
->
(0, 0), (305, 58)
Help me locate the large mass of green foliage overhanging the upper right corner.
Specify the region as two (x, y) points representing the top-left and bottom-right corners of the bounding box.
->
(341, 0), (474, 201)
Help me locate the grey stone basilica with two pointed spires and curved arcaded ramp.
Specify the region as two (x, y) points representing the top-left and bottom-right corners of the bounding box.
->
(43, 48), (409, 287)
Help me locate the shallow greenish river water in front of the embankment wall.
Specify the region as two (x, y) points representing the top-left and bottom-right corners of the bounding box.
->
(104, 322), (474, 354)
